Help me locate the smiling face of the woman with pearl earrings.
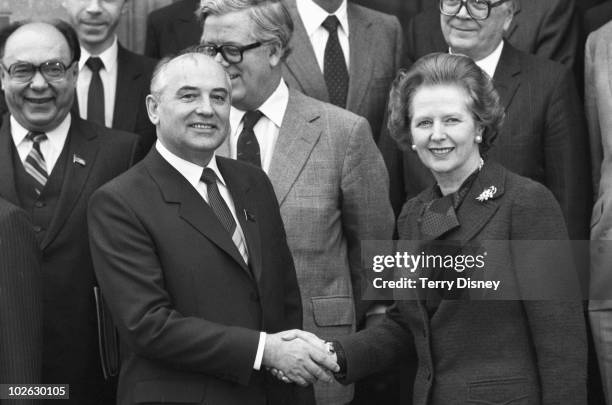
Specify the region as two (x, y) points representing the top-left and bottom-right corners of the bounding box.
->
(410, 85), (482, 187)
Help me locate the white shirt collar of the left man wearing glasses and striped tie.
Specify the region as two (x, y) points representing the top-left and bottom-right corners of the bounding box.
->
(11, 114), (72, 175)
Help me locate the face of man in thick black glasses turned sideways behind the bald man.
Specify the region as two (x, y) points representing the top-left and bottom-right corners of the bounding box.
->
(201, 10), (281, 111)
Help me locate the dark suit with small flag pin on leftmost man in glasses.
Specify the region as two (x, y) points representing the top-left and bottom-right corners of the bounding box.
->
(0, 115), (141, 405)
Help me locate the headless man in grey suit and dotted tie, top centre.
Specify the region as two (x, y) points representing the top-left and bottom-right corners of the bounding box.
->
(283, 0), (403, 141)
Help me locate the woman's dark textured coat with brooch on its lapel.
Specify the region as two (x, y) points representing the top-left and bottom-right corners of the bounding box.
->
(339, 162), (587, 405)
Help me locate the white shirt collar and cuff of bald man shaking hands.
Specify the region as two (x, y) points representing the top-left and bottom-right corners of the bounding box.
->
(155, 140), (266, 370)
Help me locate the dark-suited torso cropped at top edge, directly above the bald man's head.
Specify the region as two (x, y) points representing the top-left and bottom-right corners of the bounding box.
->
(145, 0), (202, 59)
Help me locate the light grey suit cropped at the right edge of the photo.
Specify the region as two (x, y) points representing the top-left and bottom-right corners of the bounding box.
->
(585, 19), (612, 404)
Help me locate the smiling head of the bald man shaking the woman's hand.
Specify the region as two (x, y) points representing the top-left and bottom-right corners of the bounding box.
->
(147, 54), (231, 166)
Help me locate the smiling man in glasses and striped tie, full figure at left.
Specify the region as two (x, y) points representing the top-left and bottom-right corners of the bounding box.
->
(0, 21), (138, 405)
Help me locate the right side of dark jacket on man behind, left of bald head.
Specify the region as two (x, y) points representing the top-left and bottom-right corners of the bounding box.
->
(113, 44), (142, 128)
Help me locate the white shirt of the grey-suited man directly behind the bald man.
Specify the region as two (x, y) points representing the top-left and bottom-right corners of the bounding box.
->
(229, 79), (289, 173)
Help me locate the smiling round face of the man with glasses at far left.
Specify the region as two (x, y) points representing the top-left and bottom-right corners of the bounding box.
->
(2, 23), (78, 132)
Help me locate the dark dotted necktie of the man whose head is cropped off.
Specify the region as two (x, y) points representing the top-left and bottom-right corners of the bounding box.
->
(322, 15), (349, 108)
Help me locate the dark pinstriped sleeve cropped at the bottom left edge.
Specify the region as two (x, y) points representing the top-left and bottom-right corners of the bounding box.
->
(0, 198), (42, 405)
